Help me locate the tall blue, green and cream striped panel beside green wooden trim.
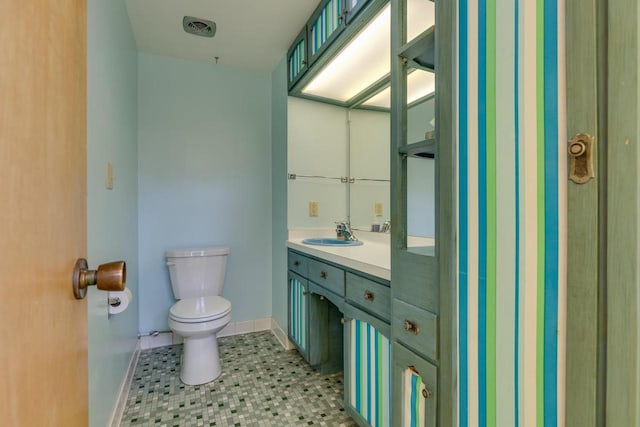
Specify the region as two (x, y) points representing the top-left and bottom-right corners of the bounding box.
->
(458, 0), (566, 427)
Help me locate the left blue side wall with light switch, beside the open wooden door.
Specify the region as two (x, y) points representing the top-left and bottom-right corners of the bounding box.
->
(86, 0), (138, 426)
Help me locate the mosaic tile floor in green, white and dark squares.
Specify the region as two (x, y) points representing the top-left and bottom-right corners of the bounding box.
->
(121, 332), (356, 427)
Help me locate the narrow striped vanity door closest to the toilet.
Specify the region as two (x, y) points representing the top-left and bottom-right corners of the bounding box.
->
(288, 272), (309, 360)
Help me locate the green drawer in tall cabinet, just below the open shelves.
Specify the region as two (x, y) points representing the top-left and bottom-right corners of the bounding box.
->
(391, 299), (438, 360)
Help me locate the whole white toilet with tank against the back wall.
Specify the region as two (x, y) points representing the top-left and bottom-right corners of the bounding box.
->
(165, 247), (231, 385)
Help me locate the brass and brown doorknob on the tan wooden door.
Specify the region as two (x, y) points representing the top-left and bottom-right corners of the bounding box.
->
(72, 258), (127, 299)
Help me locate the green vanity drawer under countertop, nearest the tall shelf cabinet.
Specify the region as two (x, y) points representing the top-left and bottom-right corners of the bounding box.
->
(346, 273), (391, 322)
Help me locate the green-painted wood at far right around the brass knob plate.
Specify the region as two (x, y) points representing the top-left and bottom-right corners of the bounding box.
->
(566, 0), (640, 426)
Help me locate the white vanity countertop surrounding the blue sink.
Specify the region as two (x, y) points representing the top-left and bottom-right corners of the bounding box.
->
(287, 229), (391, 280)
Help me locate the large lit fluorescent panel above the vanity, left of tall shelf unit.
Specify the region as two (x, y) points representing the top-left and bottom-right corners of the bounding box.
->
(302, 4), (391, 102)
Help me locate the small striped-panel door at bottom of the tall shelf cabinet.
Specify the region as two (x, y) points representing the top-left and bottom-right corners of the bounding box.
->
(393, 343), (438, 427)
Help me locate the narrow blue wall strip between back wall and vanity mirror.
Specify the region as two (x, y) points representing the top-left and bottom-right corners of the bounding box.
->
(271, 58), (288, 331)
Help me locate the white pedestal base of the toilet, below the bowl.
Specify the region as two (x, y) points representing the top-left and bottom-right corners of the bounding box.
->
(180, 334), (222, 385)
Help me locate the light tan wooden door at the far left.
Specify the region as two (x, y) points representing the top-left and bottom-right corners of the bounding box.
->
(0, 0), (88, 427)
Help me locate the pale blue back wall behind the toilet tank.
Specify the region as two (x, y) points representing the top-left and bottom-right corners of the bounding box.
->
(138, 53), (272, 333)
